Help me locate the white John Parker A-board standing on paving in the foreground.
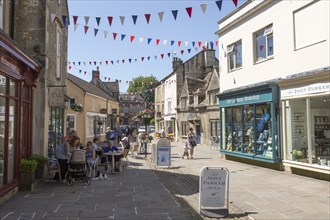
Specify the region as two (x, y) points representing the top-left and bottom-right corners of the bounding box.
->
(199, 167), (229, 217)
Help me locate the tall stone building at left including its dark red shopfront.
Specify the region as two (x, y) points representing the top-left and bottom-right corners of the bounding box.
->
(0, 0), (69, 203)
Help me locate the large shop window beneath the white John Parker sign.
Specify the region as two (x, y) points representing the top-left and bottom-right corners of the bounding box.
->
(285, 95), (330, 166)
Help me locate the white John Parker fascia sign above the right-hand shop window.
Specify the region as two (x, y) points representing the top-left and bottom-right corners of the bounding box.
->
(281, 82), (330, 98)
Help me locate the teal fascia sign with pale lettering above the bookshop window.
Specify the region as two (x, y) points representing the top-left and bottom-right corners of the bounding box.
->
(220, 93), (272, 107)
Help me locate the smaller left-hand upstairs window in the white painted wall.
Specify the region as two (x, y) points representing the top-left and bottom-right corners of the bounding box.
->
(227, 41), (242, 71)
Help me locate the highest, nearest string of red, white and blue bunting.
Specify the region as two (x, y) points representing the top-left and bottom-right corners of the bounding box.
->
(51, 0), (238, 27)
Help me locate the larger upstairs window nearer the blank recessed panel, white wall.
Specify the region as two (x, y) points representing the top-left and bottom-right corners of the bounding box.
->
(255, 25), (274, 62)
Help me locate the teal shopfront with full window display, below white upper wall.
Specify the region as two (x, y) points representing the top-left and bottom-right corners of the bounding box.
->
(218, 83), (281, 163)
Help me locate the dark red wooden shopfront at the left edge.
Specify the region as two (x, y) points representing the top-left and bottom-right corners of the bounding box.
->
(0, 32), (41, 201)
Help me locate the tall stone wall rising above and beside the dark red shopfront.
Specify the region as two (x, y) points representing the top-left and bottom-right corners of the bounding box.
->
(13, 0), (69, 156)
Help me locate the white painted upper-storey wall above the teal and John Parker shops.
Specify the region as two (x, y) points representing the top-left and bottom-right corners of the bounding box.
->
(219, 0), (330, 92)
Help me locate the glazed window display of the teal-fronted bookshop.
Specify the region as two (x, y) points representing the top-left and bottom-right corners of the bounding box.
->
(222, 104), (278, 158)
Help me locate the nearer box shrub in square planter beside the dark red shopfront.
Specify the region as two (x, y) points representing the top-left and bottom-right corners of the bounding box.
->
(19, 159), (38, 191)
